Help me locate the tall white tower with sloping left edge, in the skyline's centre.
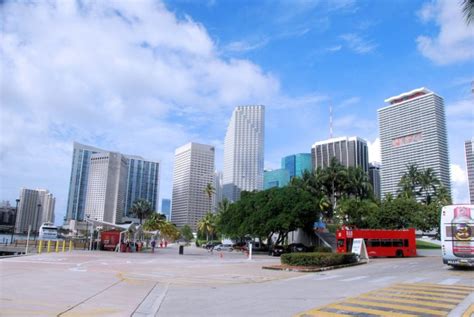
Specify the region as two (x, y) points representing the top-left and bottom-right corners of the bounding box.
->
(223, 106), (265, 201)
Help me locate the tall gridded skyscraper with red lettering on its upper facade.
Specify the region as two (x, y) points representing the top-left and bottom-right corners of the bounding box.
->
(378, 88), (451, 198)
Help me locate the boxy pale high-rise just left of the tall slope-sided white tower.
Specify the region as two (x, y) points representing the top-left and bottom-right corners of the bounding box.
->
(171, 143), (215, 232)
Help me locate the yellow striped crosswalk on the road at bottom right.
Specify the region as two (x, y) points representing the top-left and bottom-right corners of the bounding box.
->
(297, 277), (474, 317)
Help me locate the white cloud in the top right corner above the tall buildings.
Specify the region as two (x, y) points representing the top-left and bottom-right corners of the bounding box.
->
(416, 0), (474, 65)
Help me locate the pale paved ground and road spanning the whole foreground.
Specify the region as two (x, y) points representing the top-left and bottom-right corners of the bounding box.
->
(0, 246), (474, 317)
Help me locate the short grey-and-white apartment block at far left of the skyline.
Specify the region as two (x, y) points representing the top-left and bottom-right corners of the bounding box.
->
(15, 188), (56, 233)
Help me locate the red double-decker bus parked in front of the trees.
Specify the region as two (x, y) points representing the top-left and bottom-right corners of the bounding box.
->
(336, 228), (416, 257)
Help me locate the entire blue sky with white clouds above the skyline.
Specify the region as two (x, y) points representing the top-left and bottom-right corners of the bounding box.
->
(0, 0), (474, 222)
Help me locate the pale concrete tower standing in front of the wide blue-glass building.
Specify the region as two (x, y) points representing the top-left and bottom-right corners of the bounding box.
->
(84, 152), (128, 223)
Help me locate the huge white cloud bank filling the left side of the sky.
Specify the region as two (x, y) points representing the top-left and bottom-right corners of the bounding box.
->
(0, 1), (280, 221)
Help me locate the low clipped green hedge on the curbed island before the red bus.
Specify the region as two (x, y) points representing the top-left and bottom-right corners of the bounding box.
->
(281, 252), (357, 267)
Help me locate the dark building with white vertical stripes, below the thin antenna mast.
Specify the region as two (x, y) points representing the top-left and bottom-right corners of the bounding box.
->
(311, 136), (369, 173)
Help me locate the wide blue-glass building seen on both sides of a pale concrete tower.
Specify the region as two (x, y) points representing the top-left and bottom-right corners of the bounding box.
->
(65, 142), (160, 221)
